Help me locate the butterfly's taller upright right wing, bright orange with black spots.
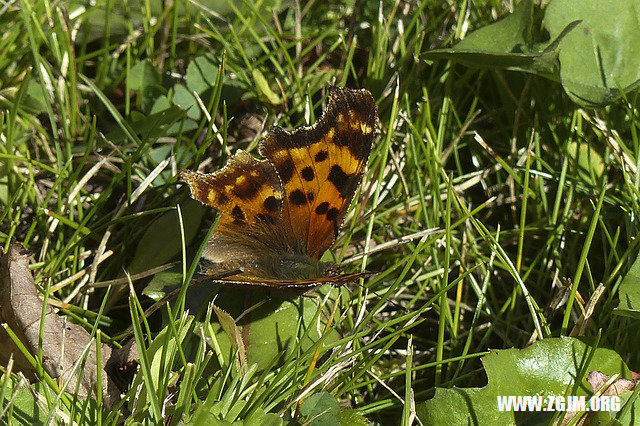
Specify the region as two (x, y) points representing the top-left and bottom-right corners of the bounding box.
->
(260, 88), (377, 259)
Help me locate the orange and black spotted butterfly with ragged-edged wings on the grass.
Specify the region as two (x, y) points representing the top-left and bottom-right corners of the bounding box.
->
(180, 87), (377, 288)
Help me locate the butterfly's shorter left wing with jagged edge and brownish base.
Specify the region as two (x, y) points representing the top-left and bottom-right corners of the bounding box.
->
(180, 150), (286, 277)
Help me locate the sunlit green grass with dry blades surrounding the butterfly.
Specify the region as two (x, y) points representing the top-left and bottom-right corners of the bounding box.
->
(0, 0), (640, 424)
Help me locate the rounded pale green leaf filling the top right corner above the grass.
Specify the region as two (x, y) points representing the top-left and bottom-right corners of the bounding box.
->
(543, 0), (640, 106)
